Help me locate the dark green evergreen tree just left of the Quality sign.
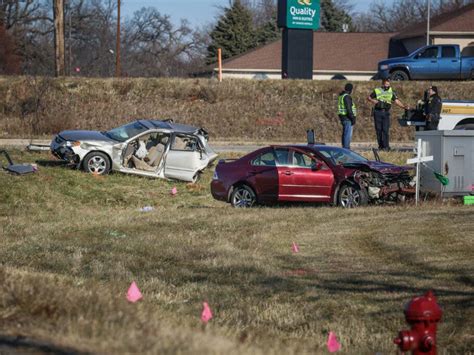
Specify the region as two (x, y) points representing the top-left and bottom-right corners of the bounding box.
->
(207, 0), (257, 64)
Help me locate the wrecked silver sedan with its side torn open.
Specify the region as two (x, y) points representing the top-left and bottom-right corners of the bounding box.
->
(50, 120), (217, 182)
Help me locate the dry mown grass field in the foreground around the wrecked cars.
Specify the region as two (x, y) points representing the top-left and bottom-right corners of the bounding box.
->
(0, 151), (474, 354)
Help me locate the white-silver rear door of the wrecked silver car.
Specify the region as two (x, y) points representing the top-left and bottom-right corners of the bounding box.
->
(164, 133), (208, 181)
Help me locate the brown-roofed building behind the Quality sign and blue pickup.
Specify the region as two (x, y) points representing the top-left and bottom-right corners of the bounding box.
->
(214, 4), (474, 80)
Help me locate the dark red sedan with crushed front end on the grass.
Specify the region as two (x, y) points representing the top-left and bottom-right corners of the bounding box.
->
(211, 144), (415, 208)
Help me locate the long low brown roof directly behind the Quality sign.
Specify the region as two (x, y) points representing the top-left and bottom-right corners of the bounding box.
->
(223, 32), (394, 72)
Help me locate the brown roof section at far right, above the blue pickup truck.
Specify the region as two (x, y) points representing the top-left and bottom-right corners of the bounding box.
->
(394, 4), (474, 39)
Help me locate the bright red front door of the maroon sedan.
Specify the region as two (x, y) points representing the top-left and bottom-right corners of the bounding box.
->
(278, 149), (334, 202)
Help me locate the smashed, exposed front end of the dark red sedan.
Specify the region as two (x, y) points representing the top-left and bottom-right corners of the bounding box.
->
(345, 163), (415, 203)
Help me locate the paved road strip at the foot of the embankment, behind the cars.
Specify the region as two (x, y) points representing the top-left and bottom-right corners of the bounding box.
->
(0, 139), (415, 153)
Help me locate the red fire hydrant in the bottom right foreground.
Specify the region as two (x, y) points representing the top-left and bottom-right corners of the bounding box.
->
(393, 291), (443, 355)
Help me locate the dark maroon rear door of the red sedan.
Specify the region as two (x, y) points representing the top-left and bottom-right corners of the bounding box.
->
(246, 147), (278, 202)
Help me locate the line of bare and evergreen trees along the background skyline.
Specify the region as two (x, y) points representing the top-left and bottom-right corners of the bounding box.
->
(0, 0), (474, 77)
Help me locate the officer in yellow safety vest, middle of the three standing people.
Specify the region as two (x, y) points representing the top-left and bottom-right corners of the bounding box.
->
(367, 78), (409, 150)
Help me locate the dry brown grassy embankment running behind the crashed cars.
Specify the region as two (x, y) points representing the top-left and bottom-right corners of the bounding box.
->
(0, 77), (474, 142)
